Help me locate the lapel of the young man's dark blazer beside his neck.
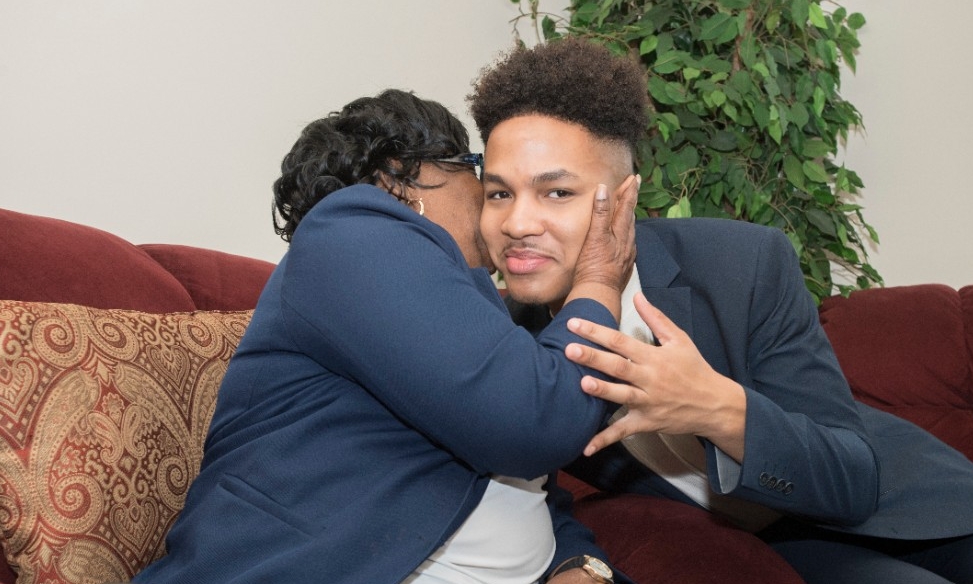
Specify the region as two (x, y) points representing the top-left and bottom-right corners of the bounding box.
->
(635, 228), (693, 338)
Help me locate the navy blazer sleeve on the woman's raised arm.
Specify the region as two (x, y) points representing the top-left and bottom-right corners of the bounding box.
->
(282, 195), (617, 478)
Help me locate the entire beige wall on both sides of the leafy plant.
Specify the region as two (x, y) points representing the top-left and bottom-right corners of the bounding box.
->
(0, 0), (973, 286)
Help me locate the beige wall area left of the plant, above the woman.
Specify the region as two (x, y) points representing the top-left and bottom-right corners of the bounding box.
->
(0, 0), (532, 261)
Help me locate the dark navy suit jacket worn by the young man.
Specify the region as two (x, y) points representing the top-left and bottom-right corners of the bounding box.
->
(508, 219), (973, 539)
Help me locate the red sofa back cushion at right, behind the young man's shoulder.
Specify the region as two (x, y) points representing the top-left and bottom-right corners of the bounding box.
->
(820, 284), (973, 459)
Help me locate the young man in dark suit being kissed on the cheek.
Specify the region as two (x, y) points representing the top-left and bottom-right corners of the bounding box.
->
(469, 39), (973, 584)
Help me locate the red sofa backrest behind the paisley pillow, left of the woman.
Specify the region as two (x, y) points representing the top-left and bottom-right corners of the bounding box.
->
(0, 209), (274, 313)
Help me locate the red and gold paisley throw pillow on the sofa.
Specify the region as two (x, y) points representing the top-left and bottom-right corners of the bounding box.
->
(0, 300), (252, 584)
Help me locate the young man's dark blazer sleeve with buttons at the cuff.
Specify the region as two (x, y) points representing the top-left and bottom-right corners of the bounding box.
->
(708, 230), (878, 525)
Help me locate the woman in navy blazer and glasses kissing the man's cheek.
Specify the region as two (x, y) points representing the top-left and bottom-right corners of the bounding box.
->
(135, 90), (637, 584)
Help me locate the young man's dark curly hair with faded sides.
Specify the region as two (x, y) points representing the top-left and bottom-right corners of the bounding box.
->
(466, 37), (648, 155)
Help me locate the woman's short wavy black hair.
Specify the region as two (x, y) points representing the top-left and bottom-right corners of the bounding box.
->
(273, 89), (469, 242)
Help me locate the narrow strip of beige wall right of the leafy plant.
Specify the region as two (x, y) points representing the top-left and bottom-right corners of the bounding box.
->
(843, 0), (973, 287)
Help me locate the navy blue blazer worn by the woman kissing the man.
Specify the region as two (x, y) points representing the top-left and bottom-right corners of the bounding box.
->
(134, 185), (617, 584)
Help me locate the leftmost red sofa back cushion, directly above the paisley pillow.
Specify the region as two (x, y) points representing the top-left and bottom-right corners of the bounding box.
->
(0, 209), (195, 312)
